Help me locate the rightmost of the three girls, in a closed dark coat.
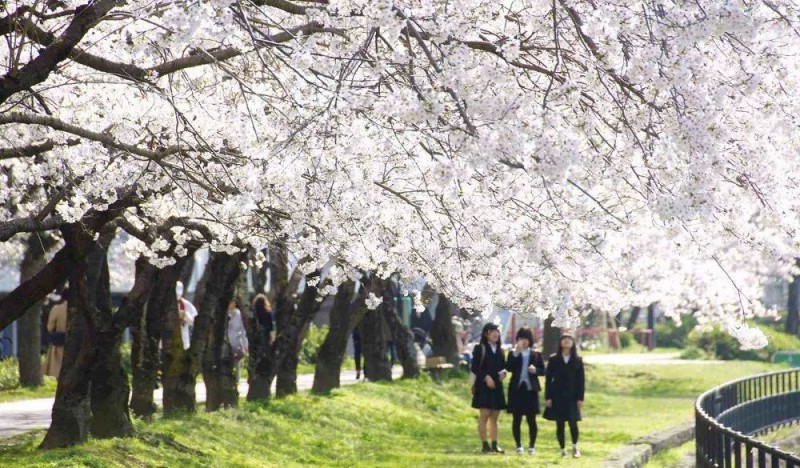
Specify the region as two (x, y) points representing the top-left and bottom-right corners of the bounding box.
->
(544, 333), (585, 458)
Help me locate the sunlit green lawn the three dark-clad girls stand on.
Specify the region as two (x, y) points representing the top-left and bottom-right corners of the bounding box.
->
(0, 361), (788, 467)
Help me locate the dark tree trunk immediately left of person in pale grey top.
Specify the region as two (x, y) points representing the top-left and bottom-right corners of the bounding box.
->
(200, 252), (242, 411)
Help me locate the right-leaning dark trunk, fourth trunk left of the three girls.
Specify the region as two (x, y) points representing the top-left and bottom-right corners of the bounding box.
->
(311, 281), (358, 393)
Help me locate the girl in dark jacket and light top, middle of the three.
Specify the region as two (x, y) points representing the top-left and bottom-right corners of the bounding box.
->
(506, 327), (545, 455)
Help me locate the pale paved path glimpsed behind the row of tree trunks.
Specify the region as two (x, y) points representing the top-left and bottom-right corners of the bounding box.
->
(0, 366), (403, 438)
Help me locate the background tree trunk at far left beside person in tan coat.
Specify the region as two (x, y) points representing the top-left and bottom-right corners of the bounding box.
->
(17, 233), (55, 387)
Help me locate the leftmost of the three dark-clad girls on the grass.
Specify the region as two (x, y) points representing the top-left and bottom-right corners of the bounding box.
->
(472, 323), (506, 453)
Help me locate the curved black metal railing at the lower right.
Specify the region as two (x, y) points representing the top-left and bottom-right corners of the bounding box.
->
(695, 369), (800, 468)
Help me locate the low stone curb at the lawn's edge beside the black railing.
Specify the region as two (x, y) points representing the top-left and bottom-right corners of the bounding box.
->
(603, 420), (694, 468)
